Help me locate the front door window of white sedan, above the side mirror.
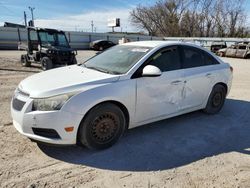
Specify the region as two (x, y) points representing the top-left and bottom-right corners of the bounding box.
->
(149, 47), (181, 72)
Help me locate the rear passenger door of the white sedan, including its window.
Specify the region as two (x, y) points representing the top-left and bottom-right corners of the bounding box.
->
(182, 46), (218, 110)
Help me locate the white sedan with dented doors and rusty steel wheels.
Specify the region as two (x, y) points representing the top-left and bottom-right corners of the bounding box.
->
(11, 41), (233, 149)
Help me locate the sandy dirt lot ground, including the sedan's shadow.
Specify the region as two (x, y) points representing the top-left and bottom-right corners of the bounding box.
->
(0, 51), (250, 188)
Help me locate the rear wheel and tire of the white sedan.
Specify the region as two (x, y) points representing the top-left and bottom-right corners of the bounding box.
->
(203, 84), (226, 114)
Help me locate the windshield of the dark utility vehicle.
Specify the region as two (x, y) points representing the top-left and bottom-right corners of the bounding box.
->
(39, 31), (68, 46)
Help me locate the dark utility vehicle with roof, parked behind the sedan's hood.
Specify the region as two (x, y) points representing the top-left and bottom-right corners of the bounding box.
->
(18, 27), (77, 70)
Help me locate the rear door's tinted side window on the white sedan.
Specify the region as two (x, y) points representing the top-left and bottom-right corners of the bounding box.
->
(183, 46), (205, 68)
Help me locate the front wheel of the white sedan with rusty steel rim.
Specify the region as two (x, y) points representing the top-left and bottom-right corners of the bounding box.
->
(78, 103), (126, 150)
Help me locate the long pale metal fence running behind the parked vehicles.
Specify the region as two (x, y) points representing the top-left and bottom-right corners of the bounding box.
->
(0, 27), (250, 50)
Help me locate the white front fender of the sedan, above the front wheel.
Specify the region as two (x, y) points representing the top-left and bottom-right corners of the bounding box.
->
(61, 79), (136, 128)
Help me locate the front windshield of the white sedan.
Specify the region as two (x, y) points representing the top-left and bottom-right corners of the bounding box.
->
(83, 45), (151, 74)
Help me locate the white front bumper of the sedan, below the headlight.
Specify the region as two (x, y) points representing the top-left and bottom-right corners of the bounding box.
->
(11, 90), (82, 145)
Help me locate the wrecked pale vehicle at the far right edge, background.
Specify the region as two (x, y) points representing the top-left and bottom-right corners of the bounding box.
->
(216, 43), (250, 58)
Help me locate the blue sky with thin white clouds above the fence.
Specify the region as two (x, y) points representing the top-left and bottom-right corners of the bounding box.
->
(0, 0), (250, 32)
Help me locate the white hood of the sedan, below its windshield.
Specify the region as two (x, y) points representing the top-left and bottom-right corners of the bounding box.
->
(18, 65), (119, 98)
